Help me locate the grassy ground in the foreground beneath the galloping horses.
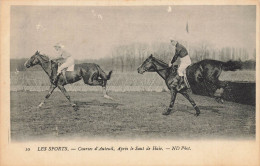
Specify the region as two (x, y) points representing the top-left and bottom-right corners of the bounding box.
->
(11, 91), (256, 141)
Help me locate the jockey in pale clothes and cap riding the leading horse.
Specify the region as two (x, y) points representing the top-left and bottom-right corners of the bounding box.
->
(53, 43), (74, 83)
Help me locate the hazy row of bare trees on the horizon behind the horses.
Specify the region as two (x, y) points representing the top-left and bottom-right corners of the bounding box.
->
(11, 42), (256, 72)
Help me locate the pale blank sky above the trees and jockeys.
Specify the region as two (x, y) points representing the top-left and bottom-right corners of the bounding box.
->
(10, 5), (256, 59)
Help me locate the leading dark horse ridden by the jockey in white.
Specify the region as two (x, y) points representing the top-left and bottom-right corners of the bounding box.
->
(24, 51), (112, 110)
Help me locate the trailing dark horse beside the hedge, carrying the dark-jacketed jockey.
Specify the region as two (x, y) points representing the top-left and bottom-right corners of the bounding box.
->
(137, 55), (241, 116)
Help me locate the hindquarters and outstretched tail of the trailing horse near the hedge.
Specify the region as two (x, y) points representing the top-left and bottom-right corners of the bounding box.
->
(186, 59), (242, 104)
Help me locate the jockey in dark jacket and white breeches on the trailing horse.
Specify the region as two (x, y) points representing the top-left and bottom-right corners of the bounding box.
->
(169, 39), (191, 90)
